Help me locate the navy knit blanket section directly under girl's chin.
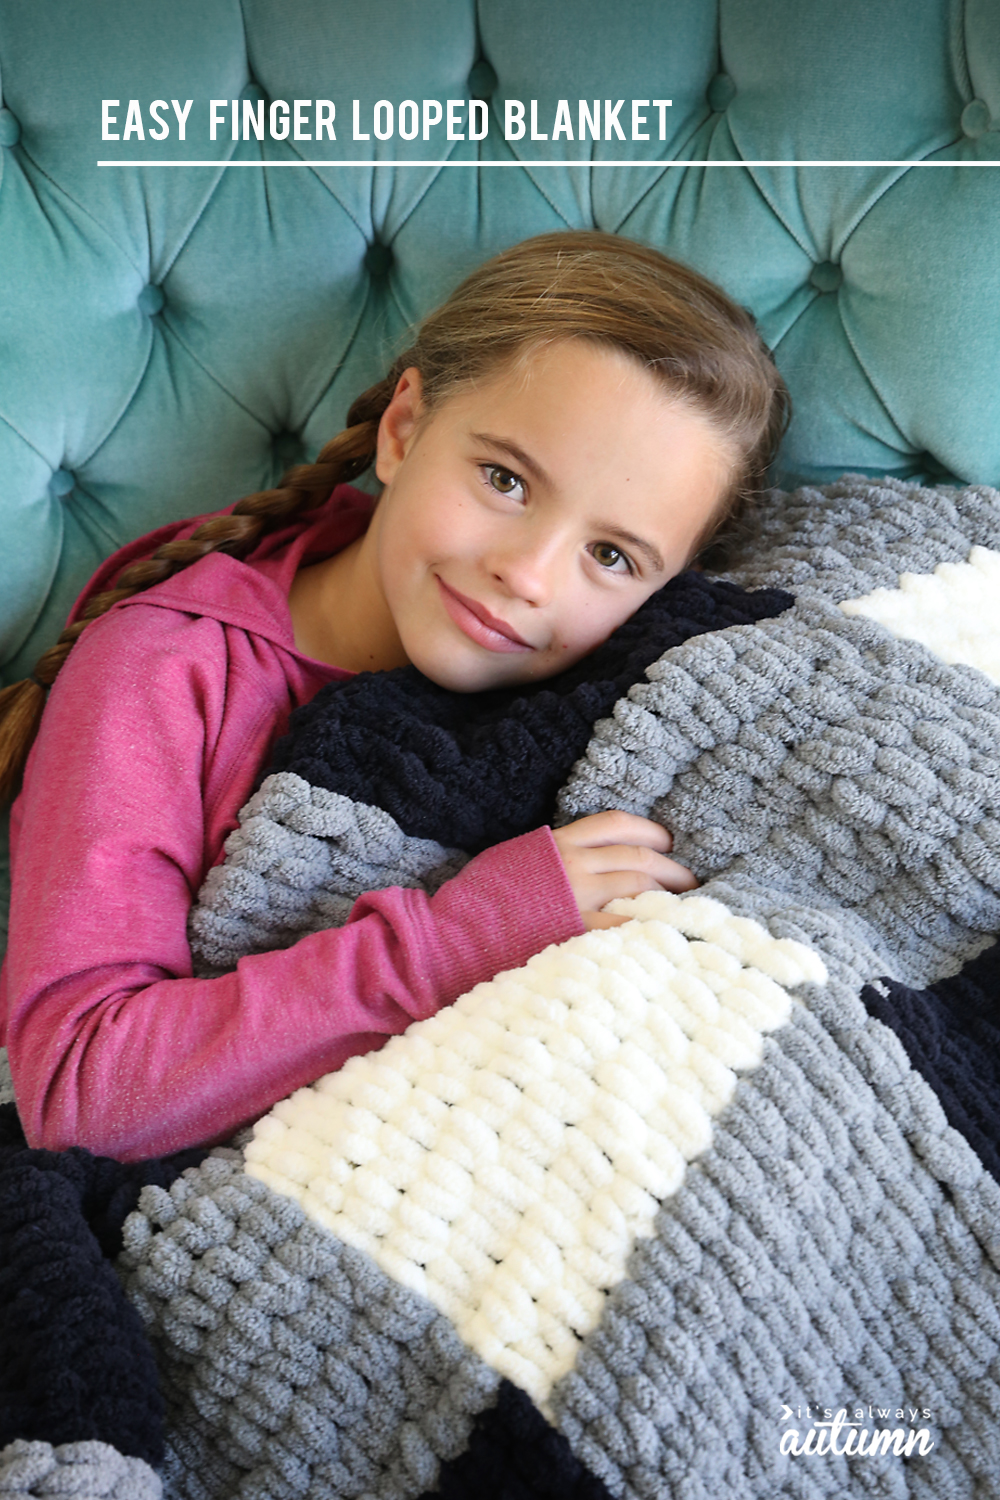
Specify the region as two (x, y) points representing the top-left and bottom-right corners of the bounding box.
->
(270, 573), (795, 854)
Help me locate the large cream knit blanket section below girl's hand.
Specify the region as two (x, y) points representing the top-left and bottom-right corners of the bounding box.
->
(246, 893), (826, 1406)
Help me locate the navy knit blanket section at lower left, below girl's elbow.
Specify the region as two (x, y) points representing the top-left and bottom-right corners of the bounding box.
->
(0, 1104), (204, 1466)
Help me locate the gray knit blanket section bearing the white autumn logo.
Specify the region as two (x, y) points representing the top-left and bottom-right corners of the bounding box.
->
(553, 882), (1000, 1500)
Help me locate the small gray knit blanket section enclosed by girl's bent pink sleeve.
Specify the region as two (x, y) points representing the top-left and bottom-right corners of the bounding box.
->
(187, 771), (469, 974)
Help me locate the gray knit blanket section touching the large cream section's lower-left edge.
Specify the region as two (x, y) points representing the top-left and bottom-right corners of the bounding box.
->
(118, 1151), (499, 1500)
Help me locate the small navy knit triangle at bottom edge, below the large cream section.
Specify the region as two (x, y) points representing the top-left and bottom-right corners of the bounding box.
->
(421, 1380), (610, 1500)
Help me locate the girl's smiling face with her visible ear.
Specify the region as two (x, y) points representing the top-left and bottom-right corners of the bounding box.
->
(360, 341), (730, 692)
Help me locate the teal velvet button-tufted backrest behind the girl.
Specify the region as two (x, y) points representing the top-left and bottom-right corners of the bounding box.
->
(0, 0), (1000, 936)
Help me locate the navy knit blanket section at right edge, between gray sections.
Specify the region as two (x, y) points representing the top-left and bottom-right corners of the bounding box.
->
(861, 944), (1000, 1182)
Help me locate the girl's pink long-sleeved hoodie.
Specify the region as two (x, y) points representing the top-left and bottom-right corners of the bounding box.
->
(0, 486), (583, 1161)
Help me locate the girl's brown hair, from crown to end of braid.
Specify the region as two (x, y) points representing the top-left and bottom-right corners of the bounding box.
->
(0, 230), (790, 798)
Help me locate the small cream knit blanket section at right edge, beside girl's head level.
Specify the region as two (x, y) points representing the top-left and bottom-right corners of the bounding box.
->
(840, 548), (1000, 683)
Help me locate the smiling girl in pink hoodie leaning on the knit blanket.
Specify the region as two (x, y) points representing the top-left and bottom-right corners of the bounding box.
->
(0, 233), (789, 1160)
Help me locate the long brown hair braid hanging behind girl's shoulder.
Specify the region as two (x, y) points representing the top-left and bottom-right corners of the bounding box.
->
(0, 405), (394, 803)
